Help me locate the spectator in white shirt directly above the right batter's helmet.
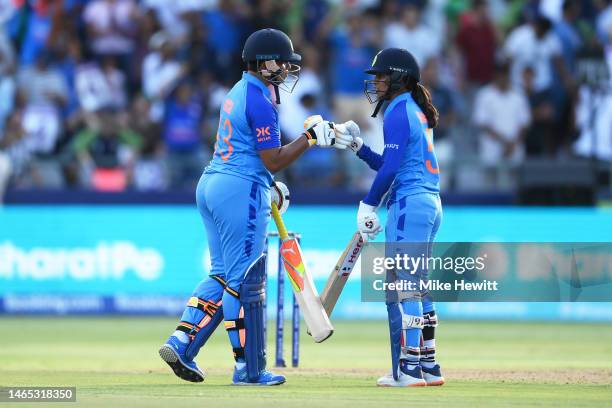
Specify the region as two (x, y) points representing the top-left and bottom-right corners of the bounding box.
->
(383, 0), (442, 66)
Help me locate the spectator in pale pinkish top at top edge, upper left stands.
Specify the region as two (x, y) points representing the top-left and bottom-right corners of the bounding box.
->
(83, 0), (140, 58)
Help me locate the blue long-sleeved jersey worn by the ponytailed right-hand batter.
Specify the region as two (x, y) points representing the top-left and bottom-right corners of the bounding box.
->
(357, 92), (440, 206)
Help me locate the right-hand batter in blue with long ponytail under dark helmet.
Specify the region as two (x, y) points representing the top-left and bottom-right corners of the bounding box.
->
(336, 48), (444, 387)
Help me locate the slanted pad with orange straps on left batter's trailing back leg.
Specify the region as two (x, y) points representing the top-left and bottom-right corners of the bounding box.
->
(185, 276), (225, 360)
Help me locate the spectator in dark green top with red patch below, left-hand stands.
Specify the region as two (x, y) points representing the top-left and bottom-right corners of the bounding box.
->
(72, 109), (142, 191)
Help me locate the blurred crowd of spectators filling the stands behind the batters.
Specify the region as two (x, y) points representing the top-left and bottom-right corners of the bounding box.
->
(0, 0), (612, 201)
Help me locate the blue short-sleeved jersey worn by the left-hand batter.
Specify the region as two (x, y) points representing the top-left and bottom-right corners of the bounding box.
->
(204, 72), (281, 187)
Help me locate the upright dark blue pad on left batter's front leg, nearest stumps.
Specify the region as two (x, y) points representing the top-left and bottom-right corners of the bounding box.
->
(225, 255), (266, 381)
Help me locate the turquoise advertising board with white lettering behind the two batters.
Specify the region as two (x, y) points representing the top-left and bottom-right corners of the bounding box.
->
(0, 206), (612, 321)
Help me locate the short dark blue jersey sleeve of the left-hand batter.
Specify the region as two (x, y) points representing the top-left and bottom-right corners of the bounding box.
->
(246, 85), (281, 150)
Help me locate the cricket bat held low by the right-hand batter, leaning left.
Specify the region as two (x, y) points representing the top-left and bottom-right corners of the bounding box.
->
(321, 231), (364, 316)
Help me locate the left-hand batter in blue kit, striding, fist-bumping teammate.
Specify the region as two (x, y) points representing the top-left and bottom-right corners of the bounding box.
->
(159, 29), (350, 385)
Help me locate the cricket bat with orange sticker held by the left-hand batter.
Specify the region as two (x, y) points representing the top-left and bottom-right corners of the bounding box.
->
(271, 203), (334, 343)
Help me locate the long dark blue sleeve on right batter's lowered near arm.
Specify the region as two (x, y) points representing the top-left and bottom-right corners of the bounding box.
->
(363, 105), (410, 206)
